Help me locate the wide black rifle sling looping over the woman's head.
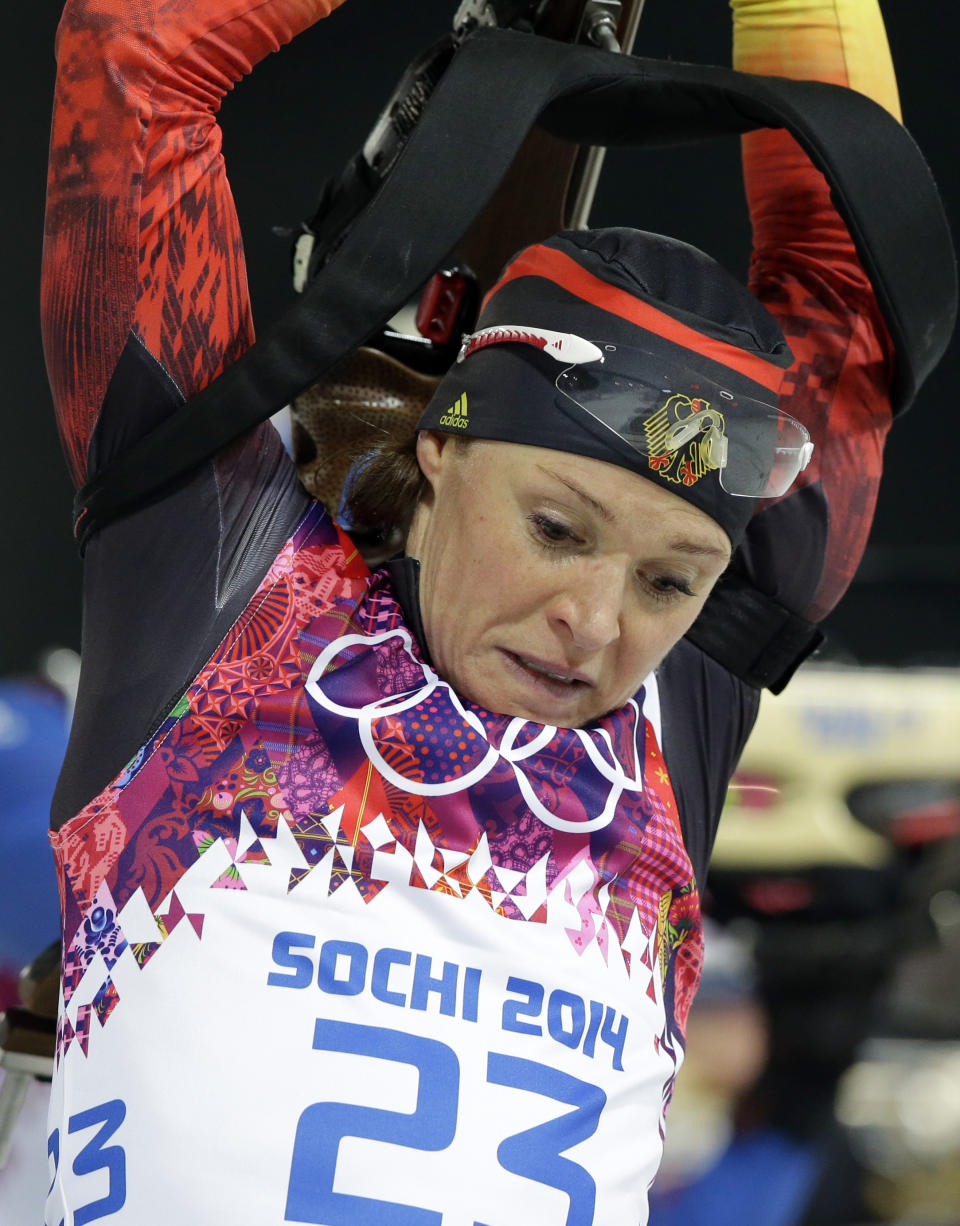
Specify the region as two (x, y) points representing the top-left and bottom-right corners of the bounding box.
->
(75, 28), (956, 684)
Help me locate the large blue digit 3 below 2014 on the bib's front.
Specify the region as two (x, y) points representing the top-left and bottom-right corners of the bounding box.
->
(487, 1052), (607, 1226)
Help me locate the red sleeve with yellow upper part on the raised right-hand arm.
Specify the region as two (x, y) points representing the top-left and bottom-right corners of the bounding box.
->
(732, 0), (899, 620)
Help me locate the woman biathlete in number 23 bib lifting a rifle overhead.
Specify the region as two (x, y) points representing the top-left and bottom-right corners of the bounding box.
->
(43, 0), (896, 1226)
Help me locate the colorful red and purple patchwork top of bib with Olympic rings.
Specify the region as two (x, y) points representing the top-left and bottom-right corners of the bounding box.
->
(51, 508), (700, 1053)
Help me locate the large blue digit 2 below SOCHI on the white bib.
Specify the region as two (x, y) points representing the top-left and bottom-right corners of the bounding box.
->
(284, 1018), (460, 1226)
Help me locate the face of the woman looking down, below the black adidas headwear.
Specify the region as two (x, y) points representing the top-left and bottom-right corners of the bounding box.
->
(407, 432), (731, 727)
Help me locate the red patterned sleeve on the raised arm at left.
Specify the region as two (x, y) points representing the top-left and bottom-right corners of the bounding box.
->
(42, 0), (341, 484)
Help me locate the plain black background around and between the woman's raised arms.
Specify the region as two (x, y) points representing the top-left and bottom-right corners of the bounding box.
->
(0, 0), (960, 674)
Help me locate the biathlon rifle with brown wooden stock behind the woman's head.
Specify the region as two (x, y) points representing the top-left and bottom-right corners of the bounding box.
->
(292, 0), (644, 522)
